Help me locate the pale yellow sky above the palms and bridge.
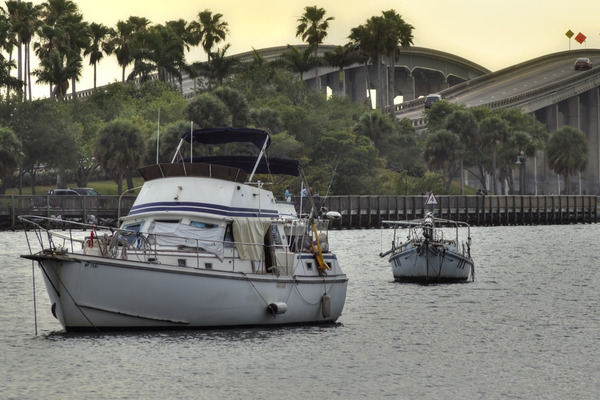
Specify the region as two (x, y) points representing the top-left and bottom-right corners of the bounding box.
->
(27, 0), (600, 97)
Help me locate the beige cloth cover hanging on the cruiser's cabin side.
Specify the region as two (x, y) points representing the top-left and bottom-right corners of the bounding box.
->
(233, 217), (271, 260)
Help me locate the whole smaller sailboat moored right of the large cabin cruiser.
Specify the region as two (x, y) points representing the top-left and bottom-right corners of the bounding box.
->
(379, 212), (475, 283)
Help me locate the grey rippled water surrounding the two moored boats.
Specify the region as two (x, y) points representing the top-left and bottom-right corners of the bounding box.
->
(0, 225), (600, 399)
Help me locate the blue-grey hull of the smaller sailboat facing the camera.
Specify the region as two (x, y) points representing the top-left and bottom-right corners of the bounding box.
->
(389, 244), (474, 283)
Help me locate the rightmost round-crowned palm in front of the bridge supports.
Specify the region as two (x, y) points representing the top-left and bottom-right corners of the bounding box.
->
(546, 126), (588, 194)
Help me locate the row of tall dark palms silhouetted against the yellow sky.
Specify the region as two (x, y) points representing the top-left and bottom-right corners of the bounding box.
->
(0, 0), (414, 112)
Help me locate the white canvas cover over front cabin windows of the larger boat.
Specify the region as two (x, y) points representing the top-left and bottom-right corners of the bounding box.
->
(148, 221), (225, 260)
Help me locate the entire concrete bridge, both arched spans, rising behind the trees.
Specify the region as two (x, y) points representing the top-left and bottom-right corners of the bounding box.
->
(67, 45), (600, 195)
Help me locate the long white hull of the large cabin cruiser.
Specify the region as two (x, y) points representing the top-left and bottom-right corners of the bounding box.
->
(29, 254), (347, 331)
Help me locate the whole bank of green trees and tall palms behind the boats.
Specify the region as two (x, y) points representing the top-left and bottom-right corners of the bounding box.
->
(0, 0), (587, 194)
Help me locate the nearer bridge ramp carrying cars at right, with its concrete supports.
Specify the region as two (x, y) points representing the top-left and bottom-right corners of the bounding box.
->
(395, 49), (600, 195)
